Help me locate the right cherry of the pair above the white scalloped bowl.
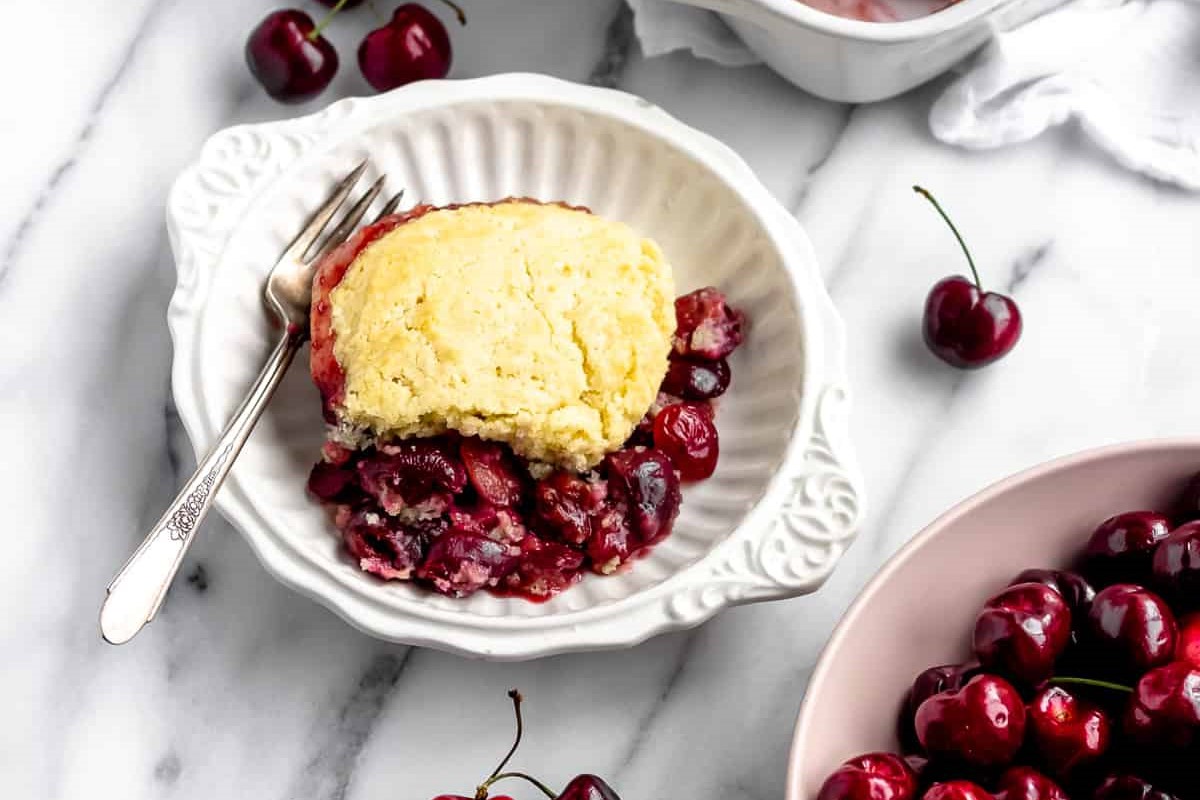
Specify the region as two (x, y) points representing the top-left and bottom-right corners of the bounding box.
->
(359, 0), (467, 91)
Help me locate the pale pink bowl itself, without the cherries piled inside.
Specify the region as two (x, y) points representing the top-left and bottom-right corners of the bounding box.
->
(787, 439), (1200, 800)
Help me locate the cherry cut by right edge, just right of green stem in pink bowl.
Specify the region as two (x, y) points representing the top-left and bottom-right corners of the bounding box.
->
(1124, 662), (1200, 750)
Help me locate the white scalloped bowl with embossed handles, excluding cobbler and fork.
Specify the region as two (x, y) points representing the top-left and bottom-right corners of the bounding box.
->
(168, 74), (863, 660)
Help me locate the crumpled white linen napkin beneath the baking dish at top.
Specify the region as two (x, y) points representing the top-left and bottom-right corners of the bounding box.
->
(628, 0), (1200, 191)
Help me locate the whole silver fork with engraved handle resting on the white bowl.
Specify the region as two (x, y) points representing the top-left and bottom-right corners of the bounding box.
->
(100, 162), (404, 644)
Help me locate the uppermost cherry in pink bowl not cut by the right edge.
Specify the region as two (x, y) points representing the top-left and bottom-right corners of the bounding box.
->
(1082, 511), (1171, 587)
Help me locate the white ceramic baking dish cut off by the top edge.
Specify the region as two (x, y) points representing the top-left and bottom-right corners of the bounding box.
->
(674, 0), (1062, 103)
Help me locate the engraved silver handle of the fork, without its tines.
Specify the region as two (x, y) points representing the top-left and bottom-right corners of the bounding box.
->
(100, 330), (306, 644)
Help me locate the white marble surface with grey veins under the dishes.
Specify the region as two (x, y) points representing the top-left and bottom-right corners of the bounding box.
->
(14, 0), (1200, 800)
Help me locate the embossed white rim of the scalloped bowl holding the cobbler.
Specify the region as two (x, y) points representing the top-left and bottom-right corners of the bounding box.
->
(168, 73), (863, 660)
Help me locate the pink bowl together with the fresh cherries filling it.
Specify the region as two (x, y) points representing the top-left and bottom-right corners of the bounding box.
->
(788, 440), (1200, 800)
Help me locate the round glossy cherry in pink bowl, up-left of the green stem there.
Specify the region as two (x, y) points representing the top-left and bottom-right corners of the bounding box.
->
(973, 583), (1070, 686)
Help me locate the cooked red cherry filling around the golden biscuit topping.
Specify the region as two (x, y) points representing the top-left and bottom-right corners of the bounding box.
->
(308, 283), (745, 601)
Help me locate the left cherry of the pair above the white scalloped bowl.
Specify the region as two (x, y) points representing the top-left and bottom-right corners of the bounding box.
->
(246, 8), (337, 103)
